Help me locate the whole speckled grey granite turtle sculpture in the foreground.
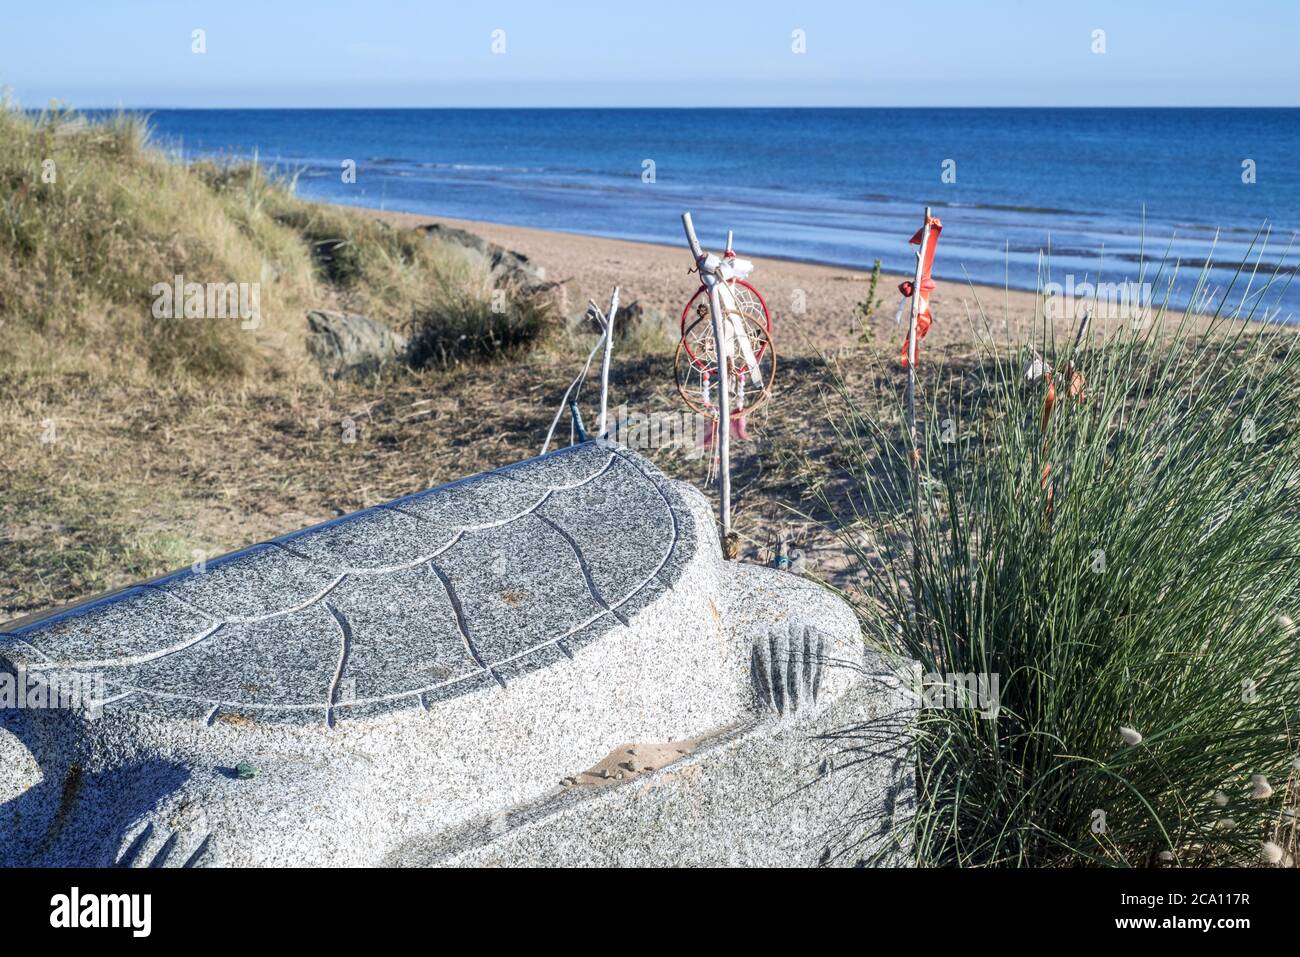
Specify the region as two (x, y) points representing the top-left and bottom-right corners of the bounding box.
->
(0, 442), (910, 866)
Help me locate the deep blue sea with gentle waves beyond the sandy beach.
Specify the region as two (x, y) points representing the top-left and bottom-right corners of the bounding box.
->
(116, 108), (1300, 321)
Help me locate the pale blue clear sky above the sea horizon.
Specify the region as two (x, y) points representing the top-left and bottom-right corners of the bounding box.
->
(0, 0), (1300, 107)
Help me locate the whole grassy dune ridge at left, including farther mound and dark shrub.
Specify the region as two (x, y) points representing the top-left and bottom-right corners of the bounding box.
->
(0, 104), (554, 381)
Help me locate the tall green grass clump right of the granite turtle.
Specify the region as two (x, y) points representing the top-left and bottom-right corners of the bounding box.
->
(826, 261), (1300, 866)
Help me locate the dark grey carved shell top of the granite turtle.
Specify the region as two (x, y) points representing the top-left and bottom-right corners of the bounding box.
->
(0, 442), (697, 727)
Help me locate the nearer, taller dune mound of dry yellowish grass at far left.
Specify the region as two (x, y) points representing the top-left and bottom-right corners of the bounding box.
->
(0, 109), (313, 378)
